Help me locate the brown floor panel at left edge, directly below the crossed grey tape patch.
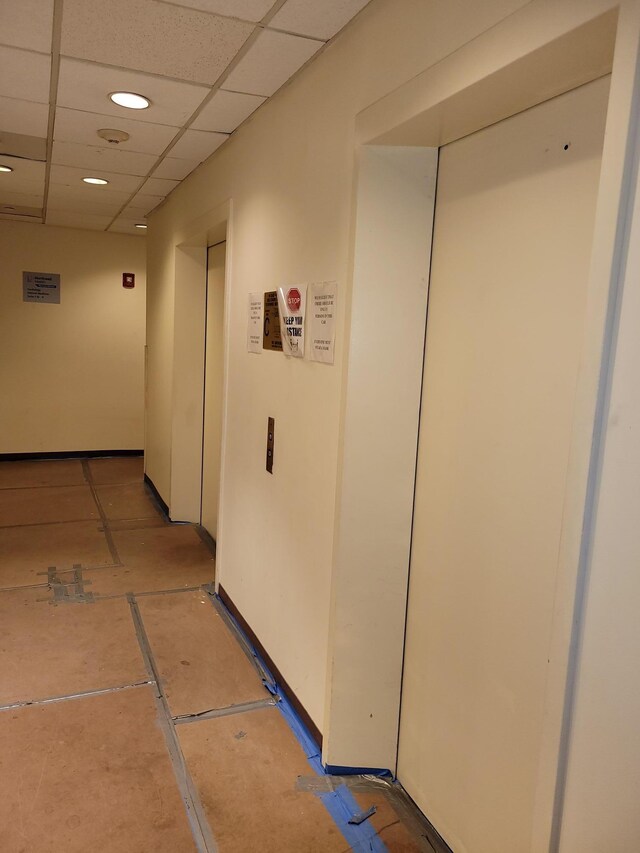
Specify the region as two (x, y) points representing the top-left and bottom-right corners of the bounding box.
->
(0, 587), (148, 705)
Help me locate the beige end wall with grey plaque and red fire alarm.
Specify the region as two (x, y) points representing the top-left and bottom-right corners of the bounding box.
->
(0, 221), (146, 453)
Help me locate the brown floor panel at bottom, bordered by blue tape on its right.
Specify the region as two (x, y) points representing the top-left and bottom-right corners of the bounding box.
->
(177, 708), (349, 853)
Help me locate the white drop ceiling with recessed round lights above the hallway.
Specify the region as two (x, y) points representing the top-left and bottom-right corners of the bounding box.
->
(0, 0), (369, 236)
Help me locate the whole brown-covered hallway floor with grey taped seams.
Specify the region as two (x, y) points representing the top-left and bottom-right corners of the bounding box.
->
(0, 457), (434, 853)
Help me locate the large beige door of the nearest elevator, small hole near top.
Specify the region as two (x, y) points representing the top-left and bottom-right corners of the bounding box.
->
(398, 78), (609, 853)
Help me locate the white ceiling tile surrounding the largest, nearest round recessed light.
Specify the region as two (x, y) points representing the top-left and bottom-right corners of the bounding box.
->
(58, 57), (210, 127)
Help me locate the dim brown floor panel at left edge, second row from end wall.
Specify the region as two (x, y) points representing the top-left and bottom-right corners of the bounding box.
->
(0, 486), (99, 527)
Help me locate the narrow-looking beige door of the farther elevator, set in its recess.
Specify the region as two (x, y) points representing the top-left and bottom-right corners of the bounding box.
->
(200, 241), (227, 540)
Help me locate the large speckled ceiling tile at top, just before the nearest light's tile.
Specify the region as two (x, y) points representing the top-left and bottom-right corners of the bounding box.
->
(61, 0), (254, 85)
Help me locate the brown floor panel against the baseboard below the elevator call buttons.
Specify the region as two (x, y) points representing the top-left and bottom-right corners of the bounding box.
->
(138, 592), (268, 716)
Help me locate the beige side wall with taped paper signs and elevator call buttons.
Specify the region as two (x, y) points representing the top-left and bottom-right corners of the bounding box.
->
(147, 0), (526, 727)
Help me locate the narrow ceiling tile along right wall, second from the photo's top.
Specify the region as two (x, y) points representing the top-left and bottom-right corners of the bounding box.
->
(224, 30), (324, 95)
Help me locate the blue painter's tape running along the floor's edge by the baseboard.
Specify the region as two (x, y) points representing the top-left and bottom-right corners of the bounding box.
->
(216, 595), (388, 853)
